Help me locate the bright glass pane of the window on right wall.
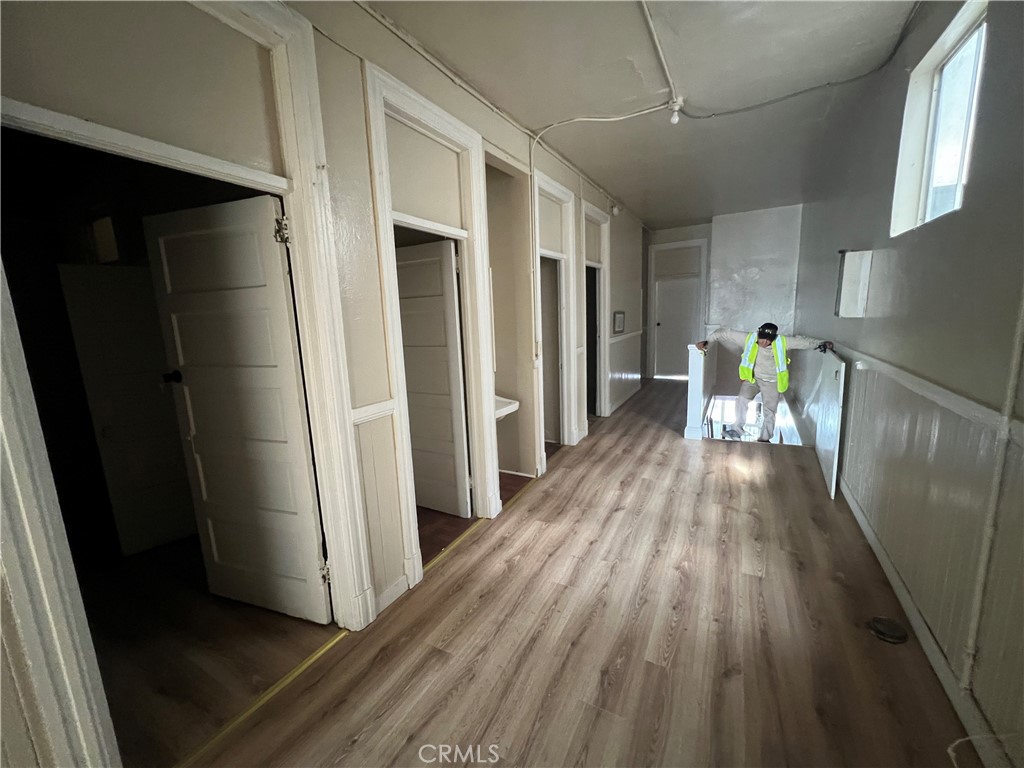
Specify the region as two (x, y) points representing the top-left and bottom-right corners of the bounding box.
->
(925, 27), (984, 221)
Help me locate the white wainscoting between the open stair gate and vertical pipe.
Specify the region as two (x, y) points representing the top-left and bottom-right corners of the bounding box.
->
(842, 367), (996, 675)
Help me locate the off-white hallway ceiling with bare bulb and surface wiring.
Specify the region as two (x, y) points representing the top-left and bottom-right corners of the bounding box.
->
(373, 1), (913, 228)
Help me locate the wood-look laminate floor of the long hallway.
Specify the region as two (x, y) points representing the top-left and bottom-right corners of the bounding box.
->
(195, 381), (974, 766)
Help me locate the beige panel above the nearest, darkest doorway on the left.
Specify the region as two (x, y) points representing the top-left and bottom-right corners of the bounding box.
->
(0, 2), (284, 174)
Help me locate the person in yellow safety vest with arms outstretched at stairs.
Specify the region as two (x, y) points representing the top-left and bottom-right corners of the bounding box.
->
(696, 323), (833, 442)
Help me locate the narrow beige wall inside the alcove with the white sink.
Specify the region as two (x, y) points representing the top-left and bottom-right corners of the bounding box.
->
(486, 165), (538, 475)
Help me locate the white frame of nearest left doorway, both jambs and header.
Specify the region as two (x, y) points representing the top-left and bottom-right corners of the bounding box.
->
(0, 3), (376, 765)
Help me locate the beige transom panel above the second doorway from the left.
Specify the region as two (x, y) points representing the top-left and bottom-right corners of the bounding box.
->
(384, 116), (462, 229)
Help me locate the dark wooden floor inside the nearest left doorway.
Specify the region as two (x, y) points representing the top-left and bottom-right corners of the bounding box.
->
(80, 538), (338, 766)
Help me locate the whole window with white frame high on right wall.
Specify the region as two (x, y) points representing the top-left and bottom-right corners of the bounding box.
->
(890, 2), (986, 236)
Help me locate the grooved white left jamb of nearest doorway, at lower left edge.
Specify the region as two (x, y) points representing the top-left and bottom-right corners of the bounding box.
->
(0, 266), (121, 766)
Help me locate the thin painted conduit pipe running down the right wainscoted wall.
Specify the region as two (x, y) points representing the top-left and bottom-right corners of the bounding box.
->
(961, 284), (1024, 690)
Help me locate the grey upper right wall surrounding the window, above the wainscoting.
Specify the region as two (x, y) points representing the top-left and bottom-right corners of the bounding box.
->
(797, 3), (1024, 416)
